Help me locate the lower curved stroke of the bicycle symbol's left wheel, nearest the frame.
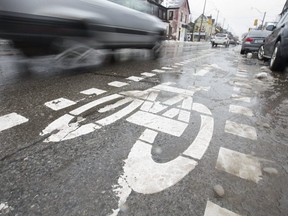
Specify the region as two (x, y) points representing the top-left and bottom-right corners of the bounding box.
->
(96, 99), (143, 126)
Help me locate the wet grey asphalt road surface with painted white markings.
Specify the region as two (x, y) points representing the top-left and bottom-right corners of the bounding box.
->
(0, 43), (288, 216)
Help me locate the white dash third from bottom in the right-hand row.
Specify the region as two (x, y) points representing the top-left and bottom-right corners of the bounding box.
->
(225, 120), (257, 140)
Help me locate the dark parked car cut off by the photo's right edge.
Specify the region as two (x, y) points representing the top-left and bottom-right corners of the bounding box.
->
(258, 11), (288, 71)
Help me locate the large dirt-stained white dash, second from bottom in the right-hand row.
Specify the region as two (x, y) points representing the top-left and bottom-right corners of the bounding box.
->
(216, 147), (262, 183)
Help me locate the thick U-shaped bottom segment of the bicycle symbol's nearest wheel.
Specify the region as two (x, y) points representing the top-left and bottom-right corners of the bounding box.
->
(120, 140), (197, 194)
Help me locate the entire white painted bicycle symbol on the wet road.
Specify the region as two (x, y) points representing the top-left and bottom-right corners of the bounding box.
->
(41, 84), (214, 215)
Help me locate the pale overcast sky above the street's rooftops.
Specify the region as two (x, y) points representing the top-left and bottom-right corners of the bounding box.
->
(189, 0), (286, 36)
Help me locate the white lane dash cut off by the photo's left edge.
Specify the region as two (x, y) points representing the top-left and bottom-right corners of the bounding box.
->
(0, 113), (29, 132)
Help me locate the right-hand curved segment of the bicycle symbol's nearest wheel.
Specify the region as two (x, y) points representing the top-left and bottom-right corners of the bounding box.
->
(183, 115), (214, 160)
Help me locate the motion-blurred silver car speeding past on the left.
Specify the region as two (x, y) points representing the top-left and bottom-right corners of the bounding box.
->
(0, 0), (165, 57)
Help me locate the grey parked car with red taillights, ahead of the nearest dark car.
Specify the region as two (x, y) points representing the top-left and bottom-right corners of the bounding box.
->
(240, 30), (271, 55)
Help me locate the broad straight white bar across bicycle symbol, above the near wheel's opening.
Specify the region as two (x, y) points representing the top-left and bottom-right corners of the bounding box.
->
(127, 111), (188, 137)
